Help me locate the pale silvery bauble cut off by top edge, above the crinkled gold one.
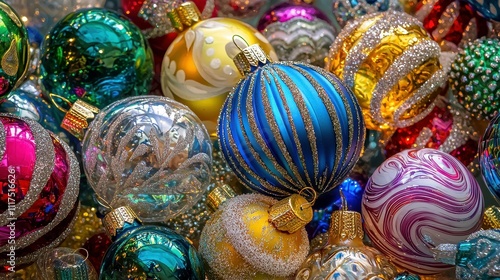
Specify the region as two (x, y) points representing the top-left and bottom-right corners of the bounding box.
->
(332, 0), (402, 27)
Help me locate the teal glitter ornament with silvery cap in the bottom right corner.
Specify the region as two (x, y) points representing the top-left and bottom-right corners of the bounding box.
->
(432, 230), (500, 279)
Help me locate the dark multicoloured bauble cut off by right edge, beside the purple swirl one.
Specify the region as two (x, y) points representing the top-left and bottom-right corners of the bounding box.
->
(479, 114), (500, 204)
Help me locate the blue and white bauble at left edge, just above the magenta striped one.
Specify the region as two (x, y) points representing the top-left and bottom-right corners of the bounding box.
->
(0, 81), (74, 143)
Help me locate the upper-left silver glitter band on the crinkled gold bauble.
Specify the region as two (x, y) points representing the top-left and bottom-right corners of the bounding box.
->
(343, 12), (421, 89)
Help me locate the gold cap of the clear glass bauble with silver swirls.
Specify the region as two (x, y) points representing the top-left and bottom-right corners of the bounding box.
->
(61, 100), (99, 141)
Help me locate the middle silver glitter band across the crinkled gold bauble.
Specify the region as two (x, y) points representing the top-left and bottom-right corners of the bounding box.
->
(370, 40), (440, 124)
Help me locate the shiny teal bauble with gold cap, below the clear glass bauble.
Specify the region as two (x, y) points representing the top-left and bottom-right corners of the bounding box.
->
(99, 207), (205, 280)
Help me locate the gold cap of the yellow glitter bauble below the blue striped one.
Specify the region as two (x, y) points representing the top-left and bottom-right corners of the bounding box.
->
(269, 189), (316, 233)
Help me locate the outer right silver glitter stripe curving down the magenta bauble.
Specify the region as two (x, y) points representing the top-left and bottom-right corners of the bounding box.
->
(0, 132), (80, 252)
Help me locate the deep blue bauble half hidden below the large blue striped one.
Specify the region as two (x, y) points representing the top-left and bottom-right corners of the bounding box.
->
(306, 177), (365, 239)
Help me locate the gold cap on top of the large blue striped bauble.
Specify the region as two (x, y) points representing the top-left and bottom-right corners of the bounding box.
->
(233, 36), (272, 76)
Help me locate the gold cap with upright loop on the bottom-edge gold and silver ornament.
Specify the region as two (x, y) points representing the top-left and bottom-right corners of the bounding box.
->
(328, 190), (364, 246)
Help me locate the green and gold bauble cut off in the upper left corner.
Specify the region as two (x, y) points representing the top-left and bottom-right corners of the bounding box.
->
(0, 1), (29, 98)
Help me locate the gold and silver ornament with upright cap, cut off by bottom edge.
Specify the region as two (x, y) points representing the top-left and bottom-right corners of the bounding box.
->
(295, 192), (398, 280)
